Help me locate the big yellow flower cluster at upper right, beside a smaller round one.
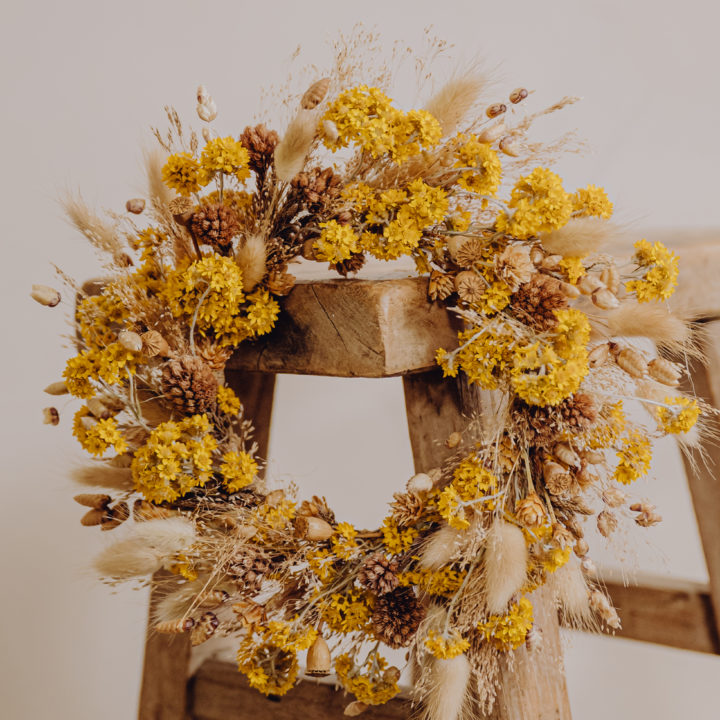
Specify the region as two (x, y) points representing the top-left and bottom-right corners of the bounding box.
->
(495, 168), (573, 240)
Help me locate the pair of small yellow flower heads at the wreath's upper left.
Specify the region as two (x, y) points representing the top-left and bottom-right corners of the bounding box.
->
(162, 137), (250, 197)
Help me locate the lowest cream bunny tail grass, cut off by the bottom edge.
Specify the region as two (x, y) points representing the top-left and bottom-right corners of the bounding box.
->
(420, 654), (471, 720)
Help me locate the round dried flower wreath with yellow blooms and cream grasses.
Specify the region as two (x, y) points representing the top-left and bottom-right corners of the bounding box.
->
(33, 38), (701, 717)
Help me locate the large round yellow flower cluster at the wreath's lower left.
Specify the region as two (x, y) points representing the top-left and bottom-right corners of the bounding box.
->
(130, 415), (217, 503)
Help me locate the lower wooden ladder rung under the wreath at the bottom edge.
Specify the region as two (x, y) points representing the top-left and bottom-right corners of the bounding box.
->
(190, 660), (409, 720)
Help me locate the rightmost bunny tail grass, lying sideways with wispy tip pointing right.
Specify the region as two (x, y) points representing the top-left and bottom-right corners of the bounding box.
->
(604, 300), (702, 358)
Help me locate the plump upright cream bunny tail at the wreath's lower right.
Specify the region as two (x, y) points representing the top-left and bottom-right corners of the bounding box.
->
(483, 519), (528, 614)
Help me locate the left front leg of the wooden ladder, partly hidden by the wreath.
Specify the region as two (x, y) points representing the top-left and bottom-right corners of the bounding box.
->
(138, 371), (275, 720)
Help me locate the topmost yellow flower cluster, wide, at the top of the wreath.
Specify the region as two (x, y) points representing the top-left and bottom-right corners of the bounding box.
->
(322, 85), (442, 163)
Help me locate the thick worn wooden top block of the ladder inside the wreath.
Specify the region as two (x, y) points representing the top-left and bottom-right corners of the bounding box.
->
(228, 278), (458, 377)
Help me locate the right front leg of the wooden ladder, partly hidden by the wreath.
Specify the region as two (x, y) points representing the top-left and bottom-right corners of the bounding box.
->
(403, 370), (571, 720)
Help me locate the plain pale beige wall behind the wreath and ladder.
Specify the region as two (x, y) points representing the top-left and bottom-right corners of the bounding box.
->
(0, 0), (720, 720)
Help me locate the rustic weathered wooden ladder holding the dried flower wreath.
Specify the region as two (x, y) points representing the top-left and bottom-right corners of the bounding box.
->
(139, 233), (720, 720)
